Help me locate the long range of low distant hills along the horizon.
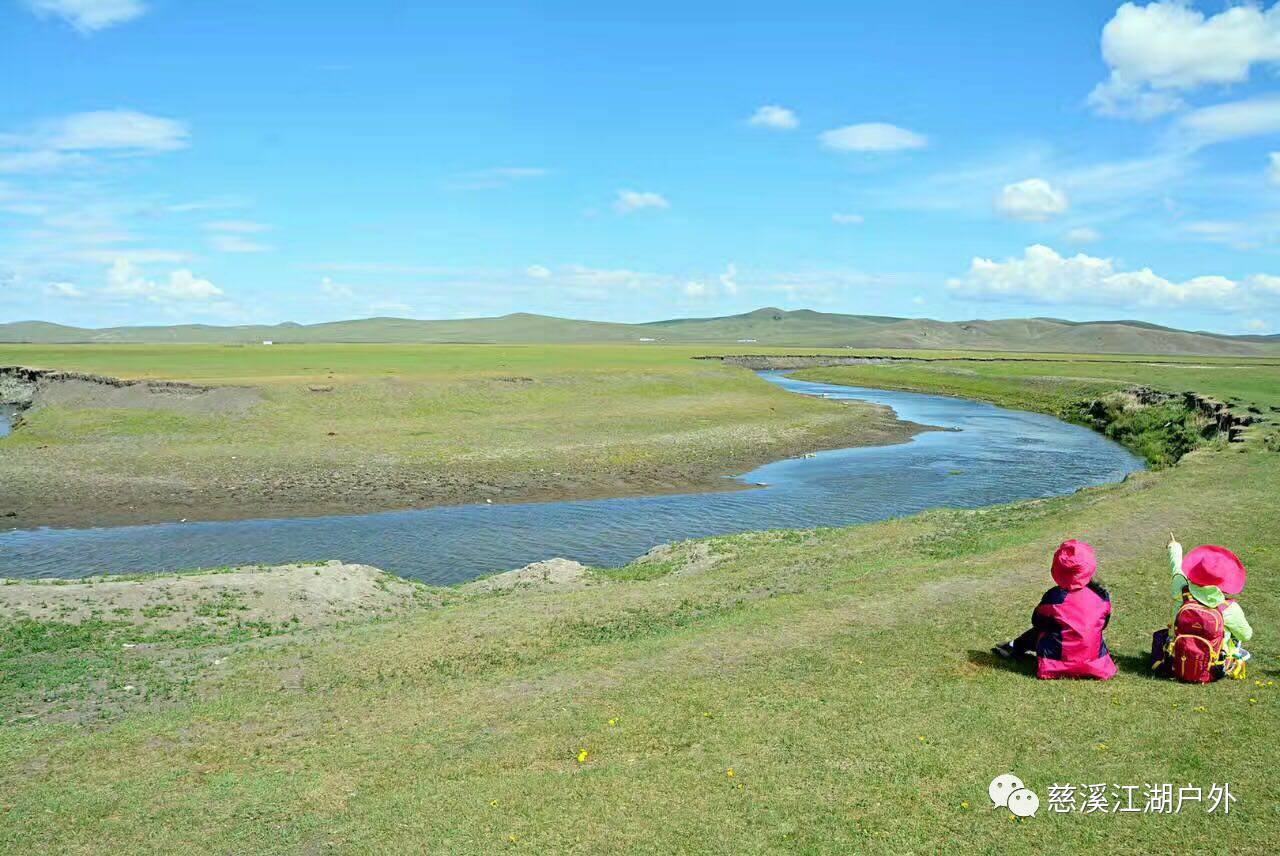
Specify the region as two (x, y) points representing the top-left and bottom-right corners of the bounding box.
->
(0, 307), (1280, 356)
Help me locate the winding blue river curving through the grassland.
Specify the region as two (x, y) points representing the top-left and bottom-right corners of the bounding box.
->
(0, 372), (1143, 583)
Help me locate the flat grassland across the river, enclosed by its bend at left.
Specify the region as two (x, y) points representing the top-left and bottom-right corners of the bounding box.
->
(0, 345), (914, 527)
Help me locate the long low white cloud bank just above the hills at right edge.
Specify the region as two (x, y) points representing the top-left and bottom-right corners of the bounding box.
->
(947, 244), (1280, 310)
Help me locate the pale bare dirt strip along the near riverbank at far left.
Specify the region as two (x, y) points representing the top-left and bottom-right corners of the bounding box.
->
(0, 562), (438, 630)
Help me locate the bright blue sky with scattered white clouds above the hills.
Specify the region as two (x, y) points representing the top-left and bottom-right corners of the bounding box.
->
(0, 0), (1280, 333)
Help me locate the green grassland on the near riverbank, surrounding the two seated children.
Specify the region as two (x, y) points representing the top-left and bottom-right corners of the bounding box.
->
(0, 348), (1280, 853)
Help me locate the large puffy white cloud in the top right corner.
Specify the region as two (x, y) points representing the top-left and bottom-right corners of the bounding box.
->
(1089, 1), (1280, 119)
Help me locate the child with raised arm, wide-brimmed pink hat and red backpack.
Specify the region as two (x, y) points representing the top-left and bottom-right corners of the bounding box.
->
(1152, 534), (1253, 683)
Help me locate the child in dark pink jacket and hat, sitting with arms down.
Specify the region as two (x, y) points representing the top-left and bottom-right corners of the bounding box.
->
(992, 540), (1116, 681)
